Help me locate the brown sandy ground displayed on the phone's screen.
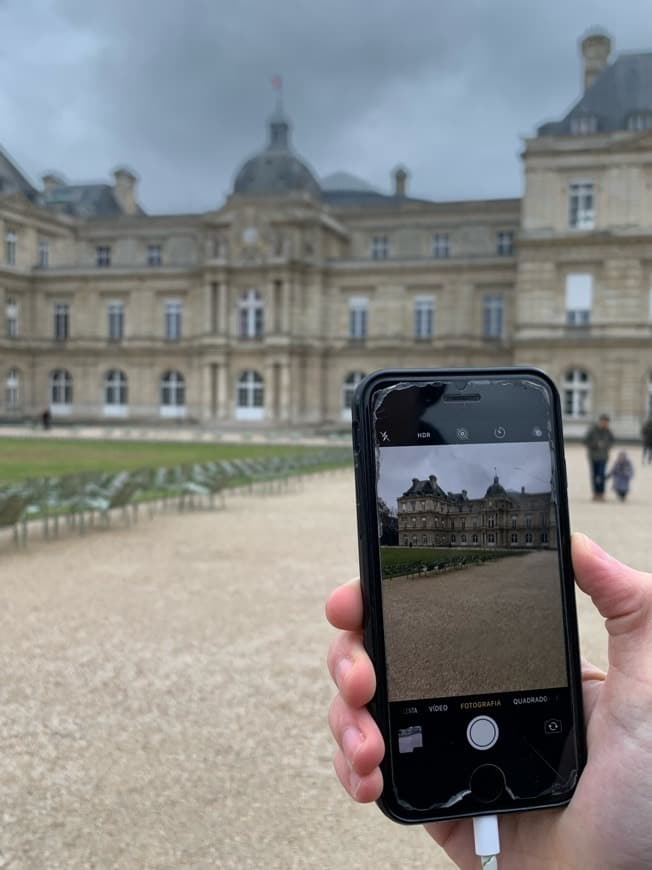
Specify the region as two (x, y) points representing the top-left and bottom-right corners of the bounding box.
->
(383, 550), (568, 701)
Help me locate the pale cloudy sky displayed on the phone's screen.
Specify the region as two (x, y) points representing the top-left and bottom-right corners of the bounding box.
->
(378, 441), (551, 511)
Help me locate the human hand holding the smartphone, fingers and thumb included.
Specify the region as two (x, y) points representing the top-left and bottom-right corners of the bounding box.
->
(326, 534), (652, 870)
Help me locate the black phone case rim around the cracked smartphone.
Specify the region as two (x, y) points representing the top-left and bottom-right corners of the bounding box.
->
(352, 366), (586, 824)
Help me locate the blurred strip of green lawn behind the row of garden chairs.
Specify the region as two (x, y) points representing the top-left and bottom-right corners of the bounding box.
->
(0, 438), (342, 483)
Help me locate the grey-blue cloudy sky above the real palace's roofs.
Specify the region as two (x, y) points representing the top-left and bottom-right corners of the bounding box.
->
(0, 0), (652, 212)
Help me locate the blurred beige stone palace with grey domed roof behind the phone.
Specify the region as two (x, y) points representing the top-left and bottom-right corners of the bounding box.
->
(0, 33), (652, 436)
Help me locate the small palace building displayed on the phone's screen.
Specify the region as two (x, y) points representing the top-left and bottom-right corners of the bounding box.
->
(397, 475), (557, 550)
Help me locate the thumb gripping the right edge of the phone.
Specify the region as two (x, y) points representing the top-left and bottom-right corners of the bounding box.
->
(572, 534), (652, 666)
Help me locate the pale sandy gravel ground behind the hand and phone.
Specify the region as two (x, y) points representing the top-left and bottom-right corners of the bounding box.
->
(0, 448), (640, 870)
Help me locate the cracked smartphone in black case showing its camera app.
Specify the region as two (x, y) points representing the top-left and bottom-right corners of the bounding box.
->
(352, 368), (586, 823)
